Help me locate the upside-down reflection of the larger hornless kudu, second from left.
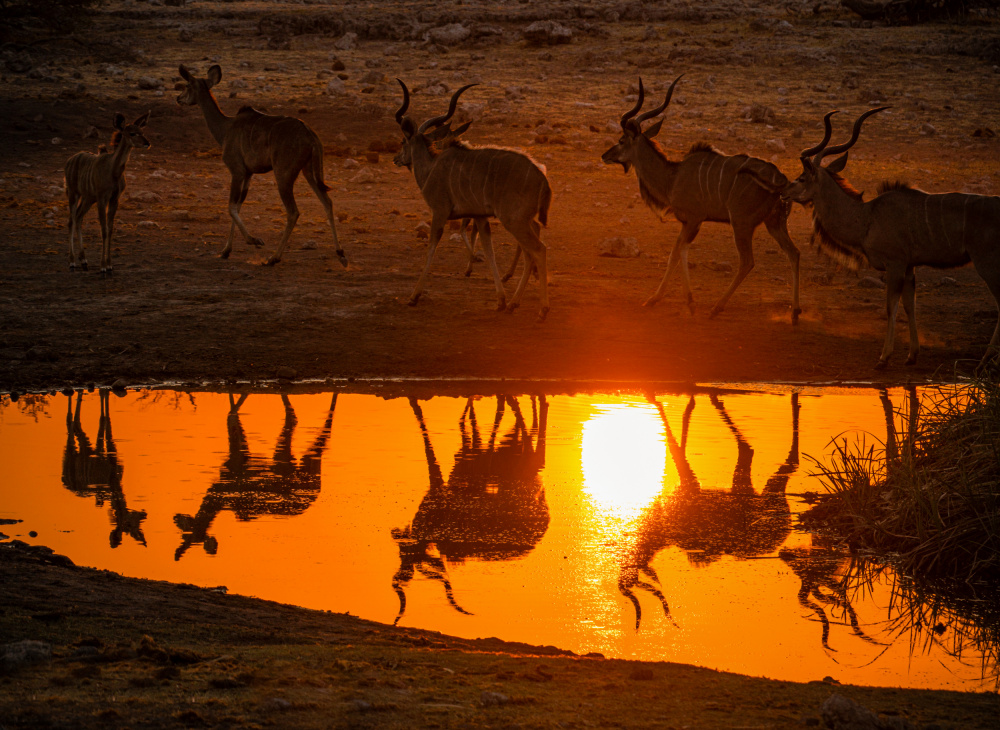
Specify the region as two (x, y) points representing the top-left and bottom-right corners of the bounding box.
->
(174, 393), (337, 560)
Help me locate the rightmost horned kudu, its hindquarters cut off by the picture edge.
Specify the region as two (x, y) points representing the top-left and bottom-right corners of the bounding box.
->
(772, 107), (1000, 369)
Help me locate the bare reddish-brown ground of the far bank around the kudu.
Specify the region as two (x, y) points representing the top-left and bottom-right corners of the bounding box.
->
(0, 2), (1000, 398)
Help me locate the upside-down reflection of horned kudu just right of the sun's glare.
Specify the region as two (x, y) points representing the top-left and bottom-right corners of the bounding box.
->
(618, 393), (799, 631)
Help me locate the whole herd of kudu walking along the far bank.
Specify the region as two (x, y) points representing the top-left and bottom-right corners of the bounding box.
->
(58, 65), (1000, 368)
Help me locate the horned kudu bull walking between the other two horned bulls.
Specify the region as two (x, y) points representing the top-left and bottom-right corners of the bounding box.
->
(601, 76), (802, 324)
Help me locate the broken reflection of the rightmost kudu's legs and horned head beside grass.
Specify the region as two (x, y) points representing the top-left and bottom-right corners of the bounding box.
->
(778, 386), (920, 651)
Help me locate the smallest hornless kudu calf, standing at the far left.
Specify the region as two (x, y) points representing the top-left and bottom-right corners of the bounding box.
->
(64, 112), (149, 276)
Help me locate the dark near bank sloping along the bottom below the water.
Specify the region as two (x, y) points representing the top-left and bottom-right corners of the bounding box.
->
(0, 540), (1000, 730)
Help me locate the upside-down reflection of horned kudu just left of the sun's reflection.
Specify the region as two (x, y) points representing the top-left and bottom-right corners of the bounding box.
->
(392, 395), (549, 624)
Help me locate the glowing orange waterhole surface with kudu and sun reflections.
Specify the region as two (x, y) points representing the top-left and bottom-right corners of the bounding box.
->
(0, 388), (996, 689)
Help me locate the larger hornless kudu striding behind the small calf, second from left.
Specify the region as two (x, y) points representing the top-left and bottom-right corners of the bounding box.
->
(177, 65), (347, 268)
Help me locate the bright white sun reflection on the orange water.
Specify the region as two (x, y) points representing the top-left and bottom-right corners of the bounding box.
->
(582, 403), (666, 522)
